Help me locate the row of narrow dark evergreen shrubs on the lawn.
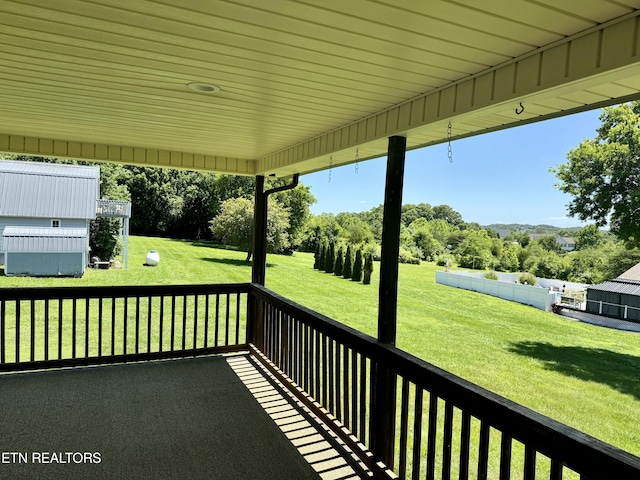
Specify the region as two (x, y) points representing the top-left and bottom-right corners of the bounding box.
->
(313, 242), (373, 284)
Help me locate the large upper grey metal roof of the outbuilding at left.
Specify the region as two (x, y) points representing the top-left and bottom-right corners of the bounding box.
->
(0, 160), (100, 219)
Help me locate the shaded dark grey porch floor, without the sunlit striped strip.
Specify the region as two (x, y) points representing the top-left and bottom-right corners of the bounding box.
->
(0, 357), (320, 480)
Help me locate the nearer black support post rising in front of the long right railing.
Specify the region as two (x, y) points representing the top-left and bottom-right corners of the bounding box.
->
(370, 137), (407, 468)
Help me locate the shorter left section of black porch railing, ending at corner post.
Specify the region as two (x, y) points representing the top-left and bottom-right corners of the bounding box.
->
(0, 284), (249, 371)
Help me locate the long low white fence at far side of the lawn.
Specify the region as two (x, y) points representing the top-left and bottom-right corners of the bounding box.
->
(436, 271), (556, 311)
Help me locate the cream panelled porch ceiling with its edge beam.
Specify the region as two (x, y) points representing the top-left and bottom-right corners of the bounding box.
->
(0, 0), (640, 176)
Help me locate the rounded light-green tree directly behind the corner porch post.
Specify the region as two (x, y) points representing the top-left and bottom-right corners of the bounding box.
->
(210, 198), (289, 262)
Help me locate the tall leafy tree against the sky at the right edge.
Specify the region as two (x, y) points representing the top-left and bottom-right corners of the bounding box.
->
(552, 101), (640, 246)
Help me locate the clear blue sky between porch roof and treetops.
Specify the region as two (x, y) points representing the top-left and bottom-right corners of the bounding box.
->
(300, 110), (601, 227)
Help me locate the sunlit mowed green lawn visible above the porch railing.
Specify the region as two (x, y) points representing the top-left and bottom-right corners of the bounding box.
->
(0, 237), (640, 462)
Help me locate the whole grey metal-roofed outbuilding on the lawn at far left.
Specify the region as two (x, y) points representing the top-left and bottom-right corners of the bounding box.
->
(0, 160), (100, 275)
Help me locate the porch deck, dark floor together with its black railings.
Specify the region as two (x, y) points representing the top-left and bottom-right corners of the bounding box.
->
(0, 284), (640, 479)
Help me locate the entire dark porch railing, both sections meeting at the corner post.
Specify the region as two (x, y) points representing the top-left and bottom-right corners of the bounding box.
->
(0, 284), (640, 479)
